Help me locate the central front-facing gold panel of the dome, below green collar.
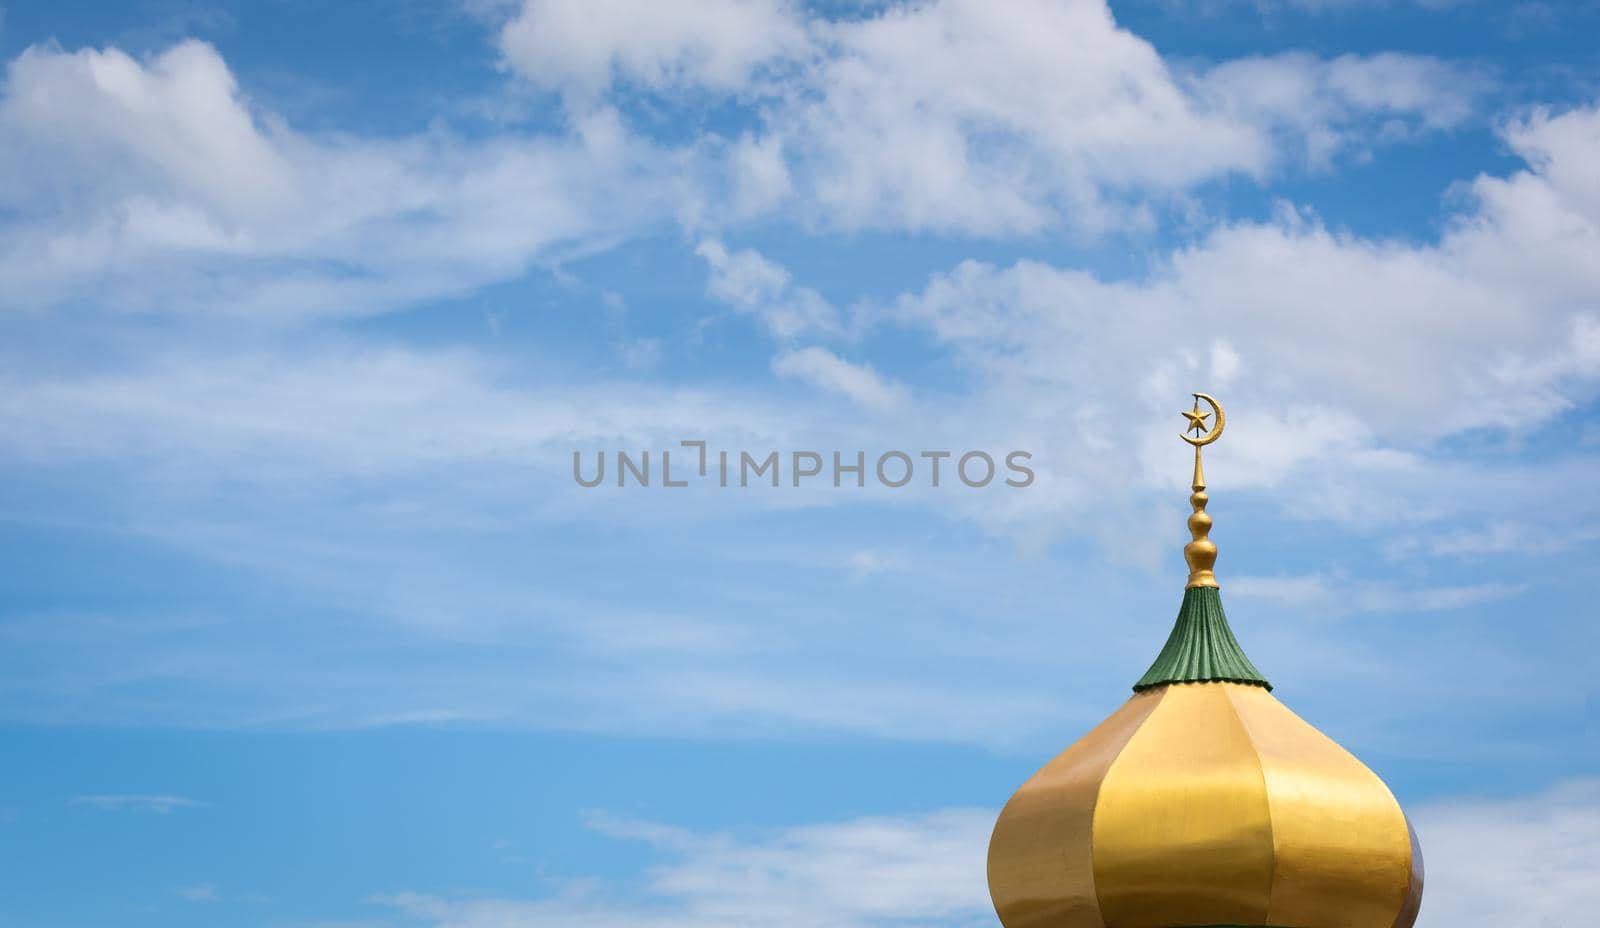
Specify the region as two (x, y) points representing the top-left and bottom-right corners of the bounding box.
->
(1094, 683), (1272, 928)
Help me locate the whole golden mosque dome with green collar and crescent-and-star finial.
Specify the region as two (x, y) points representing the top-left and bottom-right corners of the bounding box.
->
(989, 394), (1422, 928)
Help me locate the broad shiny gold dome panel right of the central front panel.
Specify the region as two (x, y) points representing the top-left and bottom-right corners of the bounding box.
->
(1224, 686), (1411, 928)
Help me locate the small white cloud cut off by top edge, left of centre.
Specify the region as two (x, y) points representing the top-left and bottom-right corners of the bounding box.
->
(499, 0), (806, 96)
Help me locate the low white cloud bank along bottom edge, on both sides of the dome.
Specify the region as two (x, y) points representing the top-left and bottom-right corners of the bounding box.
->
(376, 779), (1600, 928)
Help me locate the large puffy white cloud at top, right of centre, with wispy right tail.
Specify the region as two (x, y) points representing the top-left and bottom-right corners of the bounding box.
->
(768, 0), (1477, 235)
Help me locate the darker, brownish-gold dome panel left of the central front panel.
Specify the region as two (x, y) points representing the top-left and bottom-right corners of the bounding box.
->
(989, 690), (1165, 928)
